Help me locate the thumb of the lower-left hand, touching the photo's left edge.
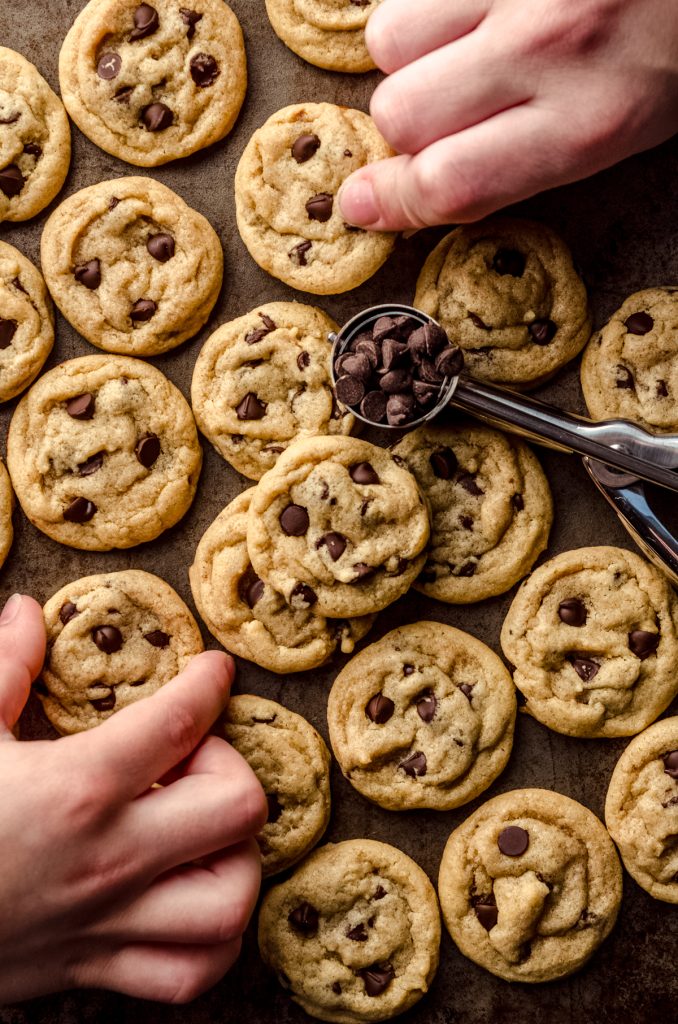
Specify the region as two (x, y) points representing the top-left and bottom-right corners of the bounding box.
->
(0, 594), (45, 738)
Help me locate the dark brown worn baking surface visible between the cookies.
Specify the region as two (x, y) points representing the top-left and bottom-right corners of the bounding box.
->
(0, 0), (678, 1024)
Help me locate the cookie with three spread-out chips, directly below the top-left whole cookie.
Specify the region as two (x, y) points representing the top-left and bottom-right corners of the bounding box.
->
(42, 177), (223, 355)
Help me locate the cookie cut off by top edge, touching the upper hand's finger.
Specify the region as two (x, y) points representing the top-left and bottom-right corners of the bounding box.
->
(266, 0), (380, 72)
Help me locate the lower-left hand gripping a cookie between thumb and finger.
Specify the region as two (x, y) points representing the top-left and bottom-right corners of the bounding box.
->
(0, 595), (267, 1004)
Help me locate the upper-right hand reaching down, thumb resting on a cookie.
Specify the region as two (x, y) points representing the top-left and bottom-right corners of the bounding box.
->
(340, 0), (678, 229)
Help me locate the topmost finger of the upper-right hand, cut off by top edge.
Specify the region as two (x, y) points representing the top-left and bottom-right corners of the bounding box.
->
(365, 0), (492, 74)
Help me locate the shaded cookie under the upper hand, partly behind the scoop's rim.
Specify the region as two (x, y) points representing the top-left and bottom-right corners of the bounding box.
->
(414, 217), (591, 387)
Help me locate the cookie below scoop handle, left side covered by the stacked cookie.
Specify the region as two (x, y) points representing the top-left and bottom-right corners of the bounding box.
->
(393, 423), (553, 604)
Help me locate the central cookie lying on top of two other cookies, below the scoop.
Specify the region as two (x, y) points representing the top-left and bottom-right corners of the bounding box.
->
(247, 437), (430, 618)
